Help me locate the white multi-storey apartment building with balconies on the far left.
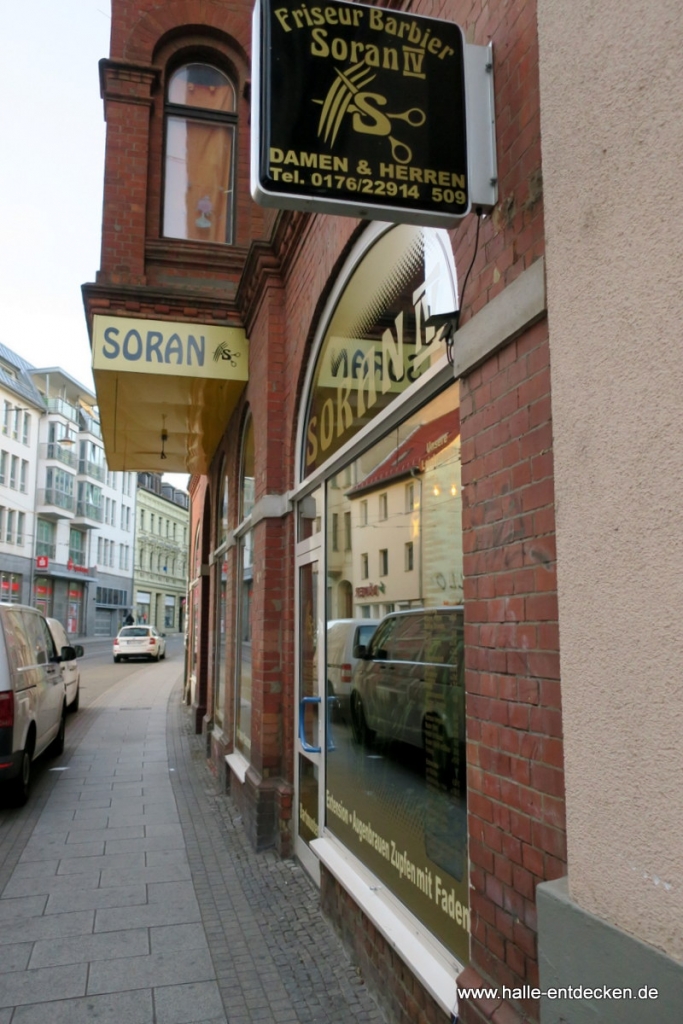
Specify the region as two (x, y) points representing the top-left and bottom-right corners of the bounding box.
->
(0, 345), (136, 636)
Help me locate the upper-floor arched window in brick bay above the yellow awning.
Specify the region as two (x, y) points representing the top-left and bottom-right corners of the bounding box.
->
(164, 63), (237, 243)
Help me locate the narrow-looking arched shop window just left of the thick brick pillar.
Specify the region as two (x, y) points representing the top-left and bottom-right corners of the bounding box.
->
(234, 417), (255, 758)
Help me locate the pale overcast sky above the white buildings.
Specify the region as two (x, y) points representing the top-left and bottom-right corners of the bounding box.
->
(0, 0), (186, 485)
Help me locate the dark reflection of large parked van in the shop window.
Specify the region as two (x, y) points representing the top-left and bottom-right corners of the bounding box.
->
(351, 607), (465, 792)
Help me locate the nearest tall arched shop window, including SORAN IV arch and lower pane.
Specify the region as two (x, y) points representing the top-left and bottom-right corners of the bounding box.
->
(299, 225), (469, 961)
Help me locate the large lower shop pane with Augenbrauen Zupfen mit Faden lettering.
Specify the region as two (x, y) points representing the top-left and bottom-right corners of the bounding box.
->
(325, 385), (469, 961)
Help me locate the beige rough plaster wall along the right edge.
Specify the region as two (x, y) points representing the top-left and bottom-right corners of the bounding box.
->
(539, 0), (683, 959)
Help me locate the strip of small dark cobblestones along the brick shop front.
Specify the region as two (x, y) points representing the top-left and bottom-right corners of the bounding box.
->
(168, 688), (386, 1024)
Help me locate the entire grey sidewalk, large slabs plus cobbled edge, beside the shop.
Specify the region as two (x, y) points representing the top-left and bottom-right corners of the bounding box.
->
(0, 664), (384, 1024)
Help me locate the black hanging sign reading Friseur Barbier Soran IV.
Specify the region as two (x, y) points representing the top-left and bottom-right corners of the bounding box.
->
(252, 0), (497, 227)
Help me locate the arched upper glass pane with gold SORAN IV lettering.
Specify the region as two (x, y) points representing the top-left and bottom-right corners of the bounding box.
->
(301, 224), (456, 473)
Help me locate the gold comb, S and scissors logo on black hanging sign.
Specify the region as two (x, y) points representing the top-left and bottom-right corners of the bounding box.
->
(313, 61), (427, 164)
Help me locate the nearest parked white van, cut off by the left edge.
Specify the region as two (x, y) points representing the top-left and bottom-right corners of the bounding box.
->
(0, 603), (70, 806)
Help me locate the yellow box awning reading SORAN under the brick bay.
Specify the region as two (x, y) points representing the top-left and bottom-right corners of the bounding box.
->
(92, 314), (249, 473)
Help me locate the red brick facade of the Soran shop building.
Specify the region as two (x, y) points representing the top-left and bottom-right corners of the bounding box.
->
(84, 0), (565, 1024)
